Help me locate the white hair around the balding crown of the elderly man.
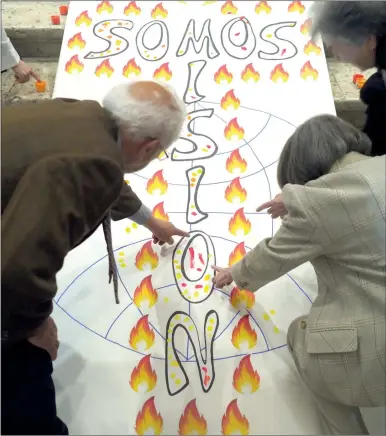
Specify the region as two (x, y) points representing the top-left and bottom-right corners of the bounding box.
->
(102, 81), (186, 149)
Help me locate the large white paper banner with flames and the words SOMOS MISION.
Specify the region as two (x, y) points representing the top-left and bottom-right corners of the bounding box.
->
(55, 1), (334, 435)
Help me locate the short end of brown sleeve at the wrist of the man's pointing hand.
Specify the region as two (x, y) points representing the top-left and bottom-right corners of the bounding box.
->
(111, 182), (152, 225)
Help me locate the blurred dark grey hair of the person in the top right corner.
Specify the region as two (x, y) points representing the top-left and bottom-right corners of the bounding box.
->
(311, 0), (386, 45)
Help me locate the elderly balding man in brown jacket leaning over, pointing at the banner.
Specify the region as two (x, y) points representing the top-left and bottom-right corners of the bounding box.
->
(1, 81), (188, 434)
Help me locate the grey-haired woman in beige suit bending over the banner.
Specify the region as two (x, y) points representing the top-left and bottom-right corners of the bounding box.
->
(213, 115), (386, 434)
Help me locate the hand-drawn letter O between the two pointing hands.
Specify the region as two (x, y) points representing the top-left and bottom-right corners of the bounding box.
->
(173, 230), (216, 304)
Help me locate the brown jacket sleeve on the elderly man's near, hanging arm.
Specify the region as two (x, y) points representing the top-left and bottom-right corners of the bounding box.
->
(1, 157), (122, 343)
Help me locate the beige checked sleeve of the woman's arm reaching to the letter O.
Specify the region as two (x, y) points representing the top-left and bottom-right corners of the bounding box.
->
(231, 185), (324, 291)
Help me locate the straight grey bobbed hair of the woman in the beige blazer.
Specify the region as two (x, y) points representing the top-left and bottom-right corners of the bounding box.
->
(277, 115), (371, 188)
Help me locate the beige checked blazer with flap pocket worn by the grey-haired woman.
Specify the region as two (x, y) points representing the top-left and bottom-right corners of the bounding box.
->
(232, 153), (386, 406)
